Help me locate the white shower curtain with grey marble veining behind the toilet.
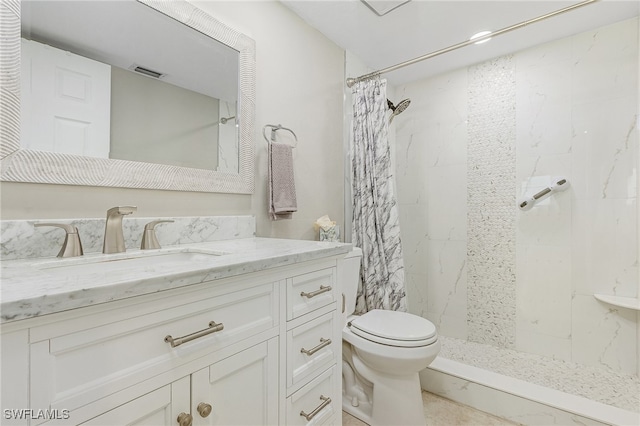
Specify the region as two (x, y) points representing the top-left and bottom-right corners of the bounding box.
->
(351, 79), (406, 313)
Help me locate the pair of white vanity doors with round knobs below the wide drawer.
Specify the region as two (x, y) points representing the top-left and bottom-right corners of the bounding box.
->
(82, 338), (278, 426)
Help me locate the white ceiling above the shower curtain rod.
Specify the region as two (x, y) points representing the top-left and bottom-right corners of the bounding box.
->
(281, 0), (640, 85)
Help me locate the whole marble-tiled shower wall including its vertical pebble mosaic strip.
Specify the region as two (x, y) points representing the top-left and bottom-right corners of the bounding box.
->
(394, 18), (639, 375)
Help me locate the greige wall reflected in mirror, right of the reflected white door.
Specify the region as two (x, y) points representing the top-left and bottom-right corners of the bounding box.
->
(109, 67), (220, 170)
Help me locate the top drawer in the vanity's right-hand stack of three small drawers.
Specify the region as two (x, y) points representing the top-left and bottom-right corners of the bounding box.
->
(287, 268), (337, 321)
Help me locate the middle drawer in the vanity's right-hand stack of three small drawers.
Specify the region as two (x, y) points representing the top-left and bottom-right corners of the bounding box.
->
(287, 311), (341, 389)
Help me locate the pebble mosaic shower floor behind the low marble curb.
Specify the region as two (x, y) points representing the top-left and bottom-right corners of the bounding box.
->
(439, 336), (640, 412)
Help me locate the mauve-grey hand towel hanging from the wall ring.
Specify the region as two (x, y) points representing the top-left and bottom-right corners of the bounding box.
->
(268, 142), (298, 220)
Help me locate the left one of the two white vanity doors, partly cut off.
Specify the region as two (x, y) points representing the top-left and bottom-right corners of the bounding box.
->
(80, 376), (190, 426)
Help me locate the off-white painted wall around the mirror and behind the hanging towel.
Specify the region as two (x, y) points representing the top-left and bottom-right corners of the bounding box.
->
(0, 1), (344, 239)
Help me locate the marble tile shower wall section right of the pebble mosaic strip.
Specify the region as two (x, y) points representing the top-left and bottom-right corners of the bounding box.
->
(516, 19), (638, 374)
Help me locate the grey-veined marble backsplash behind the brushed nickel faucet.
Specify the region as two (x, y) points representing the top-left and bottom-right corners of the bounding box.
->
(0, 213), (256, 260)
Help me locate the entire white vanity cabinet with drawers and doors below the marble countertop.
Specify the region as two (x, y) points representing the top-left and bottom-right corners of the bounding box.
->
(2, 256), (341, 426)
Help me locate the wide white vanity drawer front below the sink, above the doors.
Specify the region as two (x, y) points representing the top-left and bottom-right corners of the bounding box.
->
(30, 283), (278, 418)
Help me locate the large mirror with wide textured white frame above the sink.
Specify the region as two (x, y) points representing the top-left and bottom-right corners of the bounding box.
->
(0, 0), (255, 193)
